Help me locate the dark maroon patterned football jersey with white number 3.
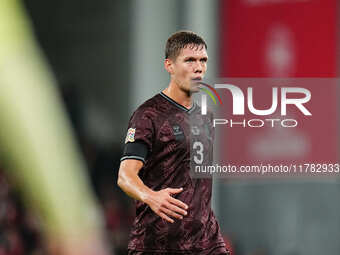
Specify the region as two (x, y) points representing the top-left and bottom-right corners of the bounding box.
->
(122, 93), (225, 254)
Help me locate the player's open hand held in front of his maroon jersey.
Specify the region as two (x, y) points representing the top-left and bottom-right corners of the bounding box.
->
(145, 188), (188, 223)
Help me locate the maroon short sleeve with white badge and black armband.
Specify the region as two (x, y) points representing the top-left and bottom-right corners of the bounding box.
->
(121, 110), (154, 163)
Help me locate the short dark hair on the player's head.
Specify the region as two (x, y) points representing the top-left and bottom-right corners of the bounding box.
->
(165, 31), (208, 59)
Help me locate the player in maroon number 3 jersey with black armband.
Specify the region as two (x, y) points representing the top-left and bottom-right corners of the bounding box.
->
(118, 31), (228, 255)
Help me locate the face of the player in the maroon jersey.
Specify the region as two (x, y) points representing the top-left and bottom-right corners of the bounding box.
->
(166, 45), (208, 93)
